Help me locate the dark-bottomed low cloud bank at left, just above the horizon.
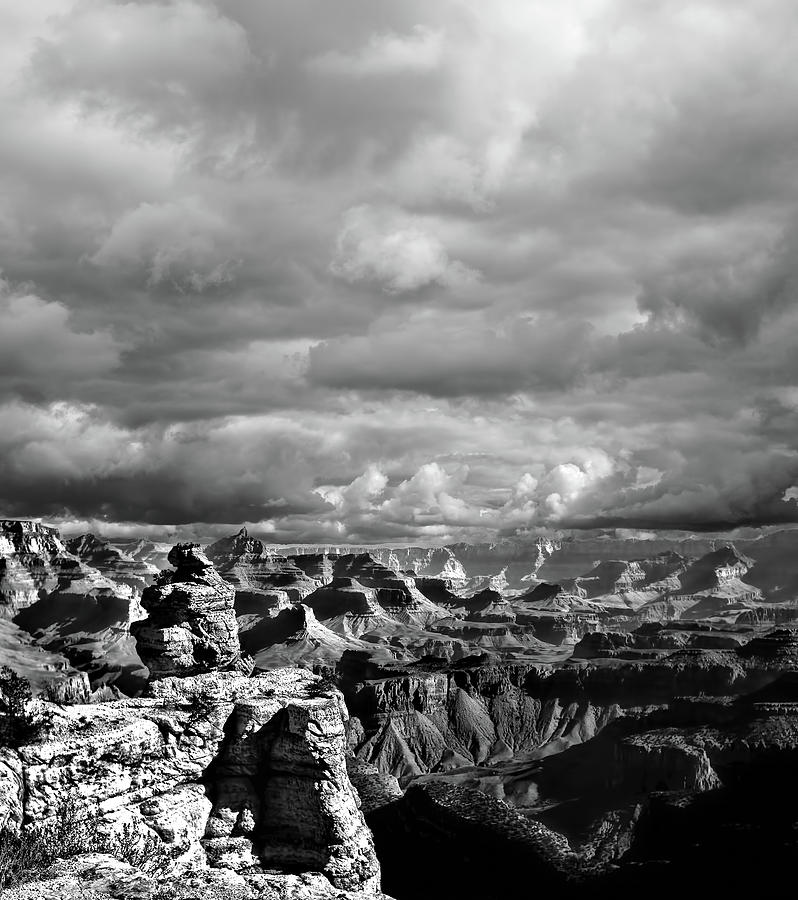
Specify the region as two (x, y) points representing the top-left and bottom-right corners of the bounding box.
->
(0, 402), (334, 525)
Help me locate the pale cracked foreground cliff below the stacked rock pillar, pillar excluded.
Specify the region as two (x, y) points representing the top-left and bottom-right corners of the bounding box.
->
(0, 669), (379, 896)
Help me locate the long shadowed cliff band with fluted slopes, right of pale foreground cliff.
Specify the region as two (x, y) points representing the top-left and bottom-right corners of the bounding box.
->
(339, 630), (798, 780)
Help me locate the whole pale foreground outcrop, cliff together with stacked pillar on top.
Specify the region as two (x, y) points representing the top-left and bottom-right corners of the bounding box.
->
(0, 544), (388, 900)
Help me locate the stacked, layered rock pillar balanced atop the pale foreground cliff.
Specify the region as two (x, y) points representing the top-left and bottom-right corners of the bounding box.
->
(131, 544), (247, 679)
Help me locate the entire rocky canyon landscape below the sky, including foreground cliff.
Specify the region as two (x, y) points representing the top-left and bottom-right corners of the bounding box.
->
(0, 520), (798, 900)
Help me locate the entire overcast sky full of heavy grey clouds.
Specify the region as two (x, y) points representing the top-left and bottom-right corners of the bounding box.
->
(0, 0), (798, 544)
